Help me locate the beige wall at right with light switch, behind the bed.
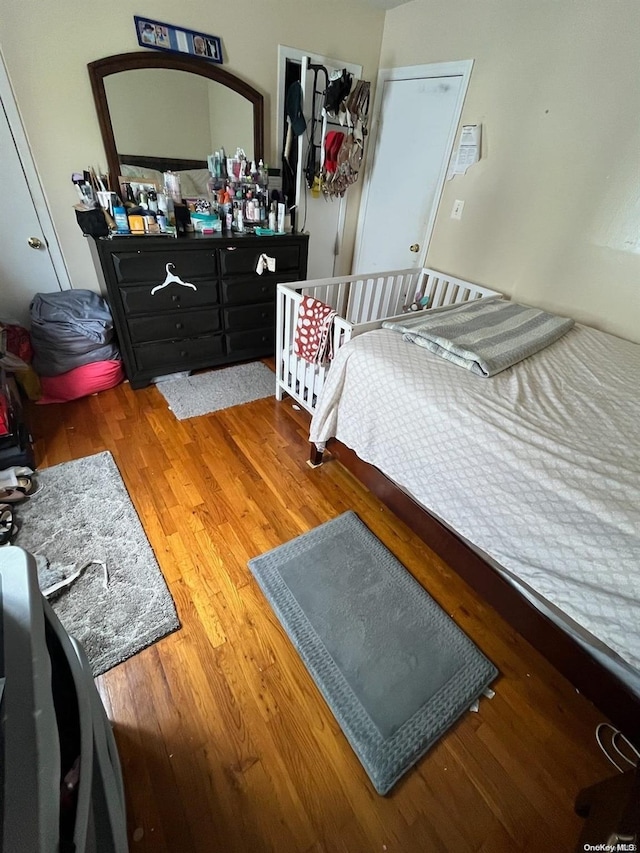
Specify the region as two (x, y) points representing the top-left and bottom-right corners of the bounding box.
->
(380, 0), (640, 341)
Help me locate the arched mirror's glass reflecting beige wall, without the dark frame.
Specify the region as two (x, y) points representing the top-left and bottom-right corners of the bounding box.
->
(104, 68), (254, 163)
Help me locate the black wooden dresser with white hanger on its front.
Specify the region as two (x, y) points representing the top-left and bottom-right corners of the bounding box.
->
(89, 234), (309, 388)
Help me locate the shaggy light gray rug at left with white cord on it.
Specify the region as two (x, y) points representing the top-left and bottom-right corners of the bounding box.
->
(14, 452), (180, 675)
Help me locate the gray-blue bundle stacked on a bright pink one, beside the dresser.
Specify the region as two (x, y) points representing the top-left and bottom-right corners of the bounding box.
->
(30, 290), (124, 403)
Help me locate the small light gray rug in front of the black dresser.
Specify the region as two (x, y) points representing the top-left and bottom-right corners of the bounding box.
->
(156, 361), (276, 421)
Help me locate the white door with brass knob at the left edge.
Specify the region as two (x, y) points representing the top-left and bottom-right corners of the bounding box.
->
(0, 53), (70, 326)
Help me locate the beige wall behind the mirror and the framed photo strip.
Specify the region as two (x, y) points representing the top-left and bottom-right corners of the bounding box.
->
(0, 0), (384, 289)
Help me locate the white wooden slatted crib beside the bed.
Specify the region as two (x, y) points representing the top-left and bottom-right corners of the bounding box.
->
(276, 267), (497, 413)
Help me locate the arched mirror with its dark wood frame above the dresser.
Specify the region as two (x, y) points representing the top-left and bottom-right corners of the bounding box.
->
(87, 51), (264, 189)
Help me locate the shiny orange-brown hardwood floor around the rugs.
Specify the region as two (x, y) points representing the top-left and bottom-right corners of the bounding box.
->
(29, 376), (615, 853)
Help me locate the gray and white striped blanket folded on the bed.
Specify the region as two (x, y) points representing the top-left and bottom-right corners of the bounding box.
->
(382, 296), (574, 377)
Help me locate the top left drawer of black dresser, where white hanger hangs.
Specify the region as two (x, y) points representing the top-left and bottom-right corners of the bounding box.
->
(111, 248), (218, 286)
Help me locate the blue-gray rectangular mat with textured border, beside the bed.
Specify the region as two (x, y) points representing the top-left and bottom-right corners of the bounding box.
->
(249, 512), (498, 794)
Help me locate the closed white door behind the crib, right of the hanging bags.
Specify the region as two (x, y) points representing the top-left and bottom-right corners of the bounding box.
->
(353, 61), (472, 273)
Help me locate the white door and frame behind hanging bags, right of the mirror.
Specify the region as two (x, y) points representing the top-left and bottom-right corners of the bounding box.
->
(278, 46), (362, 278)
